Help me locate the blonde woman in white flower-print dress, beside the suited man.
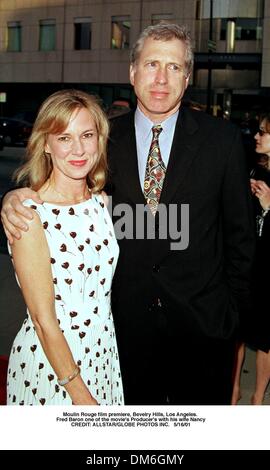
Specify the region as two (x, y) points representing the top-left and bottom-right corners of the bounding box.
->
(7, 90), (123, 405)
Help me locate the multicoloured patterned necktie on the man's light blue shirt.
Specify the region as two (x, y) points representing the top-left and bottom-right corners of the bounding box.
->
(144, 125), (166, 215)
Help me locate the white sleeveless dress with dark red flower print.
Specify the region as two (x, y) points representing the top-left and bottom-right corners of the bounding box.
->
(7, 195), (124, 405)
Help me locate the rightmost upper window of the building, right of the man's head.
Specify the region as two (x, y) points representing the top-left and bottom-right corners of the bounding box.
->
(220, 18), (262, 41)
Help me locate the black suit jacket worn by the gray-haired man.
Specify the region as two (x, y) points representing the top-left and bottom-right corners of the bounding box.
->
(109, 107), (255, 352)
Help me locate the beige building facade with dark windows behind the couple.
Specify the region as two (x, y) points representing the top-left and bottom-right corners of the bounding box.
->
(0, 0), (270, 115)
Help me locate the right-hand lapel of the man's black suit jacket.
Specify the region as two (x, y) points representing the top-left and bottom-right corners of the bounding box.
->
(160, 107), (200, 204)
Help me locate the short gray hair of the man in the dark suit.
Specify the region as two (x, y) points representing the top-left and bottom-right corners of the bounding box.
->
(130, 23), (194, 75)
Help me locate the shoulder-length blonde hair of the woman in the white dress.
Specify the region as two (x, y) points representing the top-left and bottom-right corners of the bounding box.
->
(14, 90), (109, 192)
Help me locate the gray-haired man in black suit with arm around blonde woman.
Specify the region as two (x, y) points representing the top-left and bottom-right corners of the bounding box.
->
(2, 24), (254, 405)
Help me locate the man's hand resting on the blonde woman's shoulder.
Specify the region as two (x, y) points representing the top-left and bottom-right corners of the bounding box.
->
(1, 188), (43, 245)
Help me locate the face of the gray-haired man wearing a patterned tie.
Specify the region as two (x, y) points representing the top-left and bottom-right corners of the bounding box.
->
(130, 38), (189, 122)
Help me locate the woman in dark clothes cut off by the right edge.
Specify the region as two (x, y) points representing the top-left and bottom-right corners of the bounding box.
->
(232, 113), (270, 405)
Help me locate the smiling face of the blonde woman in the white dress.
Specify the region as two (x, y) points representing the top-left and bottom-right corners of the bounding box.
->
(45, 108), (98, 180)
